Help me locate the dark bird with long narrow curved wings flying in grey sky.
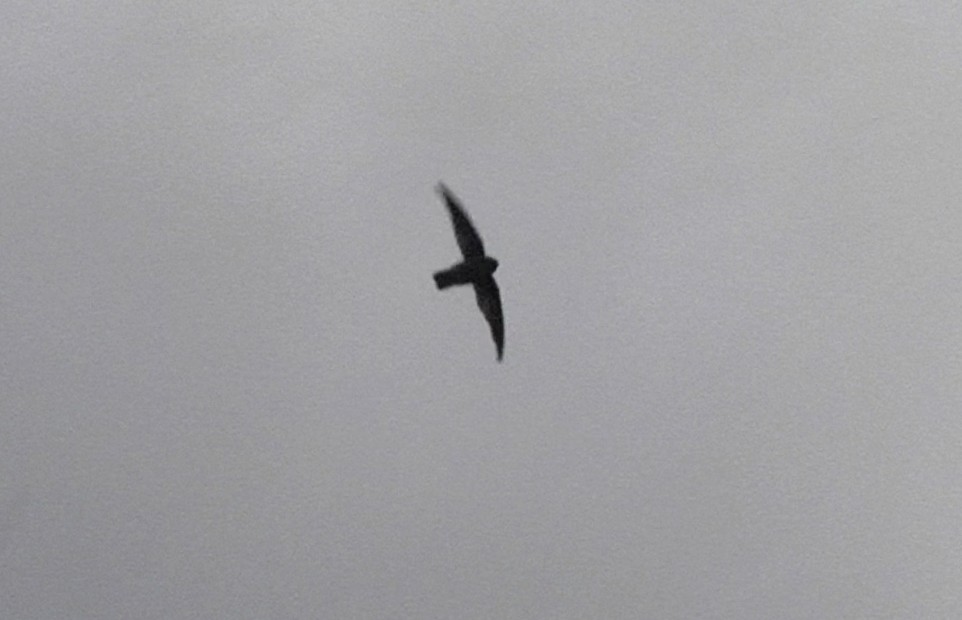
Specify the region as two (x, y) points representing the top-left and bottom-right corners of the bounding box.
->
(434, 183), (504, 362)
